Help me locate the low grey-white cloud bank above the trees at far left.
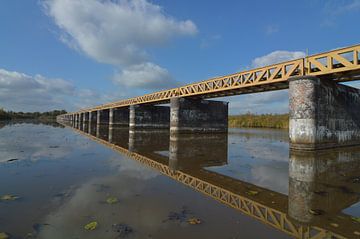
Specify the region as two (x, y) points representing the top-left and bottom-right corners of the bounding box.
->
(0, 69), (115, 112)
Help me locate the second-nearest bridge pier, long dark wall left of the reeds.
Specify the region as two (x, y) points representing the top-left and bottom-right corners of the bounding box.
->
(170, 98), (228, 134)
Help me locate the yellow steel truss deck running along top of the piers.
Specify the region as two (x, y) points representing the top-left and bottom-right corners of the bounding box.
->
(61, 45), (360, 115)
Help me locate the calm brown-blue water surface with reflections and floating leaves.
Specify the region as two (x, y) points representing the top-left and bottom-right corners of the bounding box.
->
(0, 122), (360, 239)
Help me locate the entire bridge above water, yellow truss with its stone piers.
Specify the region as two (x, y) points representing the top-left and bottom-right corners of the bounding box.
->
(59, 45), (360, 150)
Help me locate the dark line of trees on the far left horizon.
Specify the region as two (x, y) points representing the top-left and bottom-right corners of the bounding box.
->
(0, 108), (66, 120)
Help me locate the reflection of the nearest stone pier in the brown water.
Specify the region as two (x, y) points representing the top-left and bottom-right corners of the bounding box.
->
(289, 148), (360, 226)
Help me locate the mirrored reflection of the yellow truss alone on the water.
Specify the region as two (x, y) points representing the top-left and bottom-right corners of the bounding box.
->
(59, 122), (357, 239)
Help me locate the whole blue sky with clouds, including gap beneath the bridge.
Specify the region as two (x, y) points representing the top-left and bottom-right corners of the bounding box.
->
(0, 0), (360, 114)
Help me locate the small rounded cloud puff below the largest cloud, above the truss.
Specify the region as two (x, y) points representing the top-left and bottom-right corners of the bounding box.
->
(113, 63), (176, 89)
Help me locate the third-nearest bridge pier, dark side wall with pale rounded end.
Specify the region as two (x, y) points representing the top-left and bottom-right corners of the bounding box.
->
(129, 105), (170, 131)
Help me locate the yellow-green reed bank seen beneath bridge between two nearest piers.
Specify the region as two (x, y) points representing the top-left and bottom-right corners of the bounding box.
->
(229, 113), (289, 129)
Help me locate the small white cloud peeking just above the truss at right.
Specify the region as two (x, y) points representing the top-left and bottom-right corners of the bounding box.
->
(252, 51), (306, 67)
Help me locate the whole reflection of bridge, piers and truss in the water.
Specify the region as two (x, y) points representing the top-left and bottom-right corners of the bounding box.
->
(59, 121), (360, 238)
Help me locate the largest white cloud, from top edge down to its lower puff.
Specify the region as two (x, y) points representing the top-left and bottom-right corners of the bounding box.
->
(43, 0), (197, 88)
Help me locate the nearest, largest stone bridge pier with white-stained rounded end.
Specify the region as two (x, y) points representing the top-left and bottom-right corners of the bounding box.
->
(289, 77), (360, 150)
